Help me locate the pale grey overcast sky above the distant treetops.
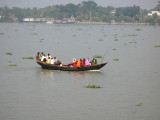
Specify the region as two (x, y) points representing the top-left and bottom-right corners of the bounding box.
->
(0, 0), (160, 10)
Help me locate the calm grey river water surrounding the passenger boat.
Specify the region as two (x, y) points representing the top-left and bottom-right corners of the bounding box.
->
(0, 23), (160, 120)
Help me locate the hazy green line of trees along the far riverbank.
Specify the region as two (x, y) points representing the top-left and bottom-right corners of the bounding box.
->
(0, 1), (160, 22)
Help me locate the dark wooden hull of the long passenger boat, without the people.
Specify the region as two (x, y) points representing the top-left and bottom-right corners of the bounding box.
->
(37, 61), (107, 71)
